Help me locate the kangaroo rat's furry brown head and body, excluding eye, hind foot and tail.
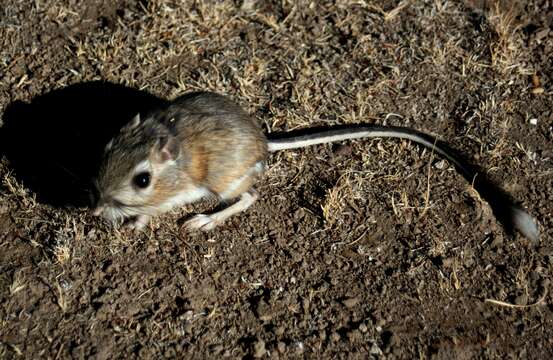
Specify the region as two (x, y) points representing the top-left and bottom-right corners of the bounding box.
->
(92, 93), (267, 228)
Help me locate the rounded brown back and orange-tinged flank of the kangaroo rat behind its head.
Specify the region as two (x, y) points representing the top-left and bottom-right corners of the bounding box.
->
(164, 93), (267, 194)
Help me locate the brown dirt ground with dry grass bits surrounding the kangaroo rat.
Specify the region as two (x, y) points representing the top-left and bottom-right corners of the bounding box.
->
(0, 0), (553, 359)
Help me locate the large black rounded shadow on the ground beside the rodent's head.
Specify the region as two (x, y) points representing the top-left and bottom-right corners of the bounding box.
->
(0, 82), (164, 207)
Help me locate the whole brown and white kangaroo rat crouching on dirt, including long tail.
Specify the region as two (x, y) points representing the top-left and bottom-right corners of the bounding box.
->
(94, 92), (538, 239)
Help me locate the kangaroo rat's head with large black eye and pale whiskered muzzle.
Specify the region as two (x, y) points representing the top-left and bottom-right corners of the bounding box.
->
(94, 114), (180, 223)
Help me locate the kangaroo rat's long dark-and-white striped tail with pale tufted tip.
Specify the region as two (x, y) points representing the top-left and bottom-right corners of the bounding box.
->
(267, 125), (539, 241)
